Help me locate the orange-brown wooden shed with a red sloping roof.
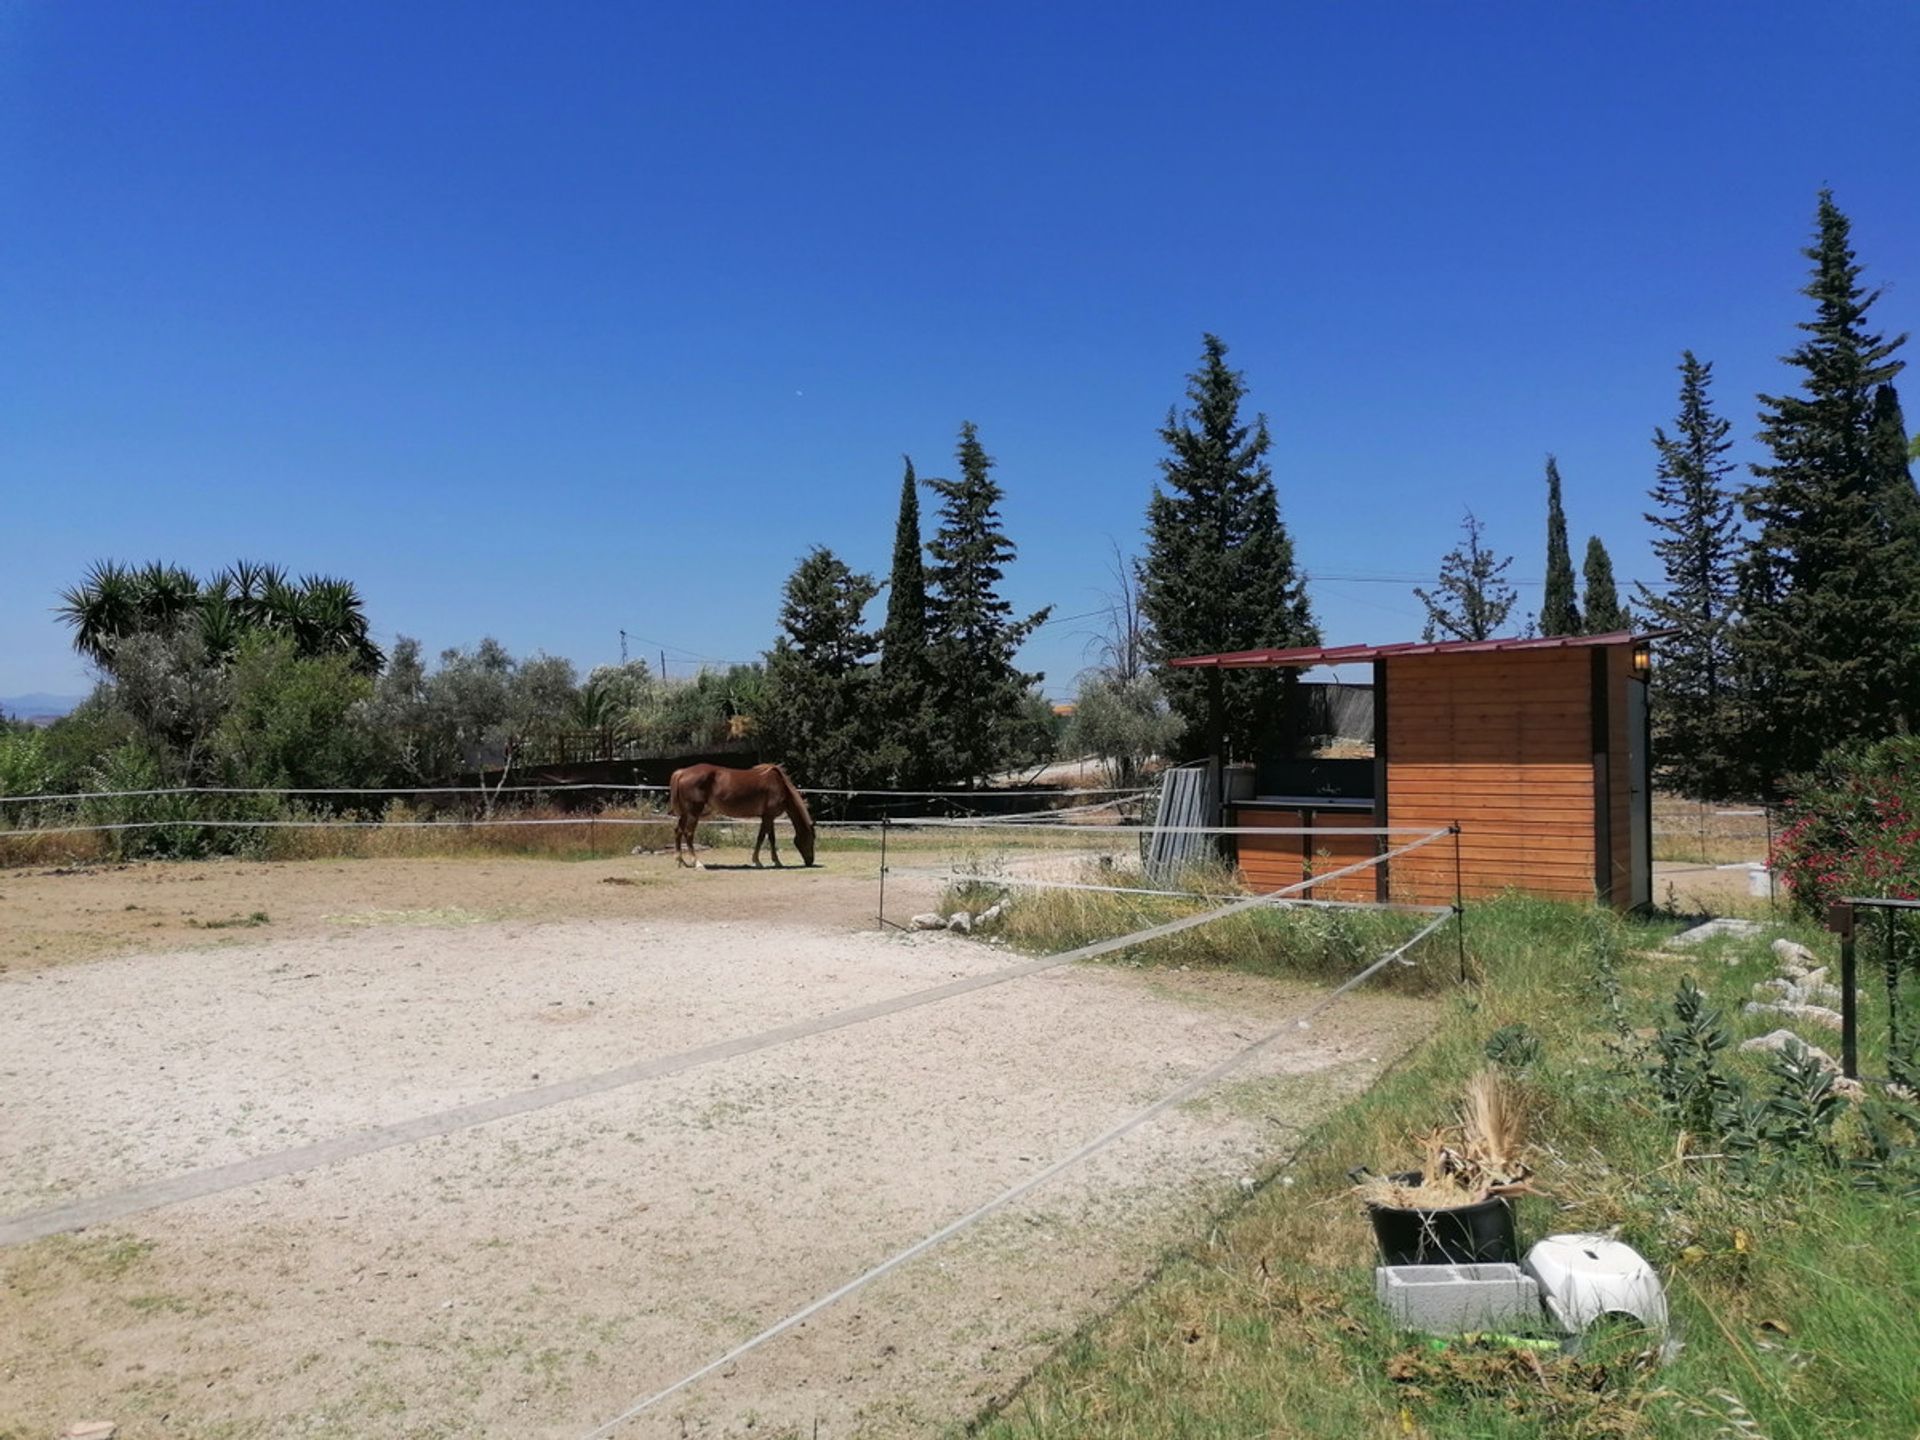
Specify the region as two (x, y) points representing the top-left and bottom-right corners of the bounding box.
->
(1173, 632), (1653, 908)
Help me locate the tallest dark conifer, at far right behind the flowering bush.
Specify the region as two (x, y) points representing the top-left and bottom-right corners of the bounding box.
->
(1736, 190), (1920, 789)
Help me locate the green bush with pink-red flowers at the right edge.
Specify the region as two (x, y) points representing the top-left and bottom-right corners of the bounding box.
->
(1772, 735), (1920, 916)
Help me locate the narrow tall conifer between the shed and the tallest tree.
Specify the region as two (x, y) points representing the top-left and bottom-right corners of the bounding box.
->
(1640, 349), (1740, 799)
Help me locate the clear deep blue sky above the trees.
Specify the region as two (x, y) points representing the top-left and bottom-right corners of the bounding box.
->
(0, 0), (1920, 695)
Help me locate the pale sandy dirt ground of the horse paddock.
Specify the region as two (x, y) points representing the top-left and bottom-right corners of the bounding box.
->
(0, 854), (1427, 1440)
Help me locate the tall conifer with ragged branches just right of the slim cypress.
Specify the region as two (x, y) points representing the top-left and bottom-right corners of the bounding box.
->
(927, 420), (1046, 781)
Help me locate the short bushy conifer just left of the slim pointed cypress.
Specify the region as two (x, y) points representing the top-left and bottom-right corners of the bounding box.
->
(760, 545), (879, 785)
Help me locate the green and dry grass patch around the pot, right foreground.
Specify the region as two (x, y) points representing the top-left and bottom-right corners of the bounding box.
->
(968, 899), (1920, 1440)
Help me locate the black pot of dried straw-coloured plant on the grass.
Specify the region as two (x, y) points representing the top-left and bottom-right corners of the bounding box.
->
(1354, 1069), (1538, 1265)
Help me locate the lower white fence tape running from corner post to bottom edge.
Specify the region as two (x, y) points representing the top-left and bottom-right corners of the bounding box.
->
(580, 906), (1455, 1440)
